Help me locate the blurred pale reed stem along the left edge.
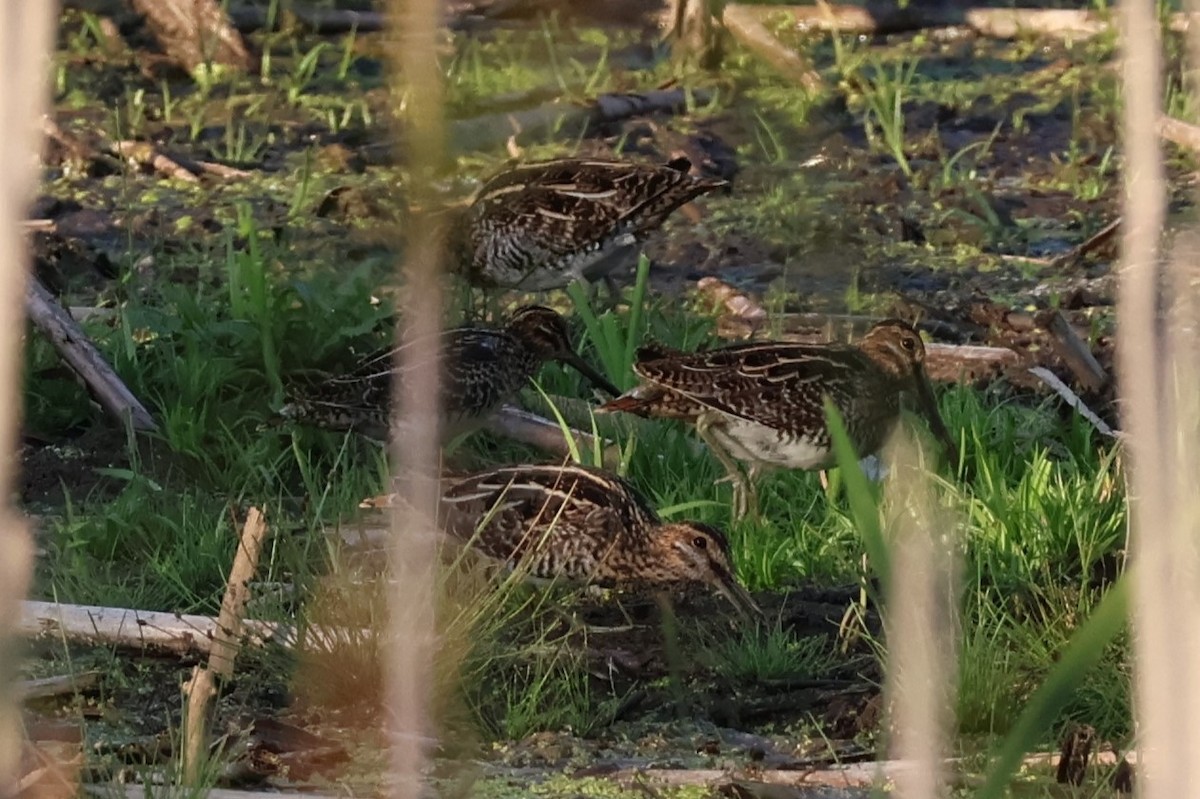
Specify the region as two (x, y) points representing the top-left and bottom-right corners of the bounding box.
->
(0, 0), (59, 795)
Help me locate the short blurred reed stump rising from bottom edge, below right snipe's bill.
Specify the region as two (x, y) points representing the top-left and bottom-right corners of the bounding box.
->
(883, 432), (958, 799)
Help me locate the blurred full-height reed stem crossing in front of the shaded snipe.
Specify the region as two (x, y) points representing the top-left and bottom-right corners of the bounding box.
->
(386, 0), (444, 799)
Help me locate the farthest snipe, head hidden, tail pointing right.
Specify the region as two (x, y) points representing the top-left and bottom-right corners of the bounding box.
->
(448, 158), (727, 292)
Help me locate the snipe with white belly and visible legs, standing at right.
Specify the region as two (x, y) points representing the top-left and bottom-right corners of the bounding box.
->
(598, 319), (955, 516)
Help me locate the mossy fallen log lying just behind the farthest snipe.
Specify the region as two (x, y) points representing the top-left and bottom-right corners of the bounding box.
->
(450, 89), (709, 152)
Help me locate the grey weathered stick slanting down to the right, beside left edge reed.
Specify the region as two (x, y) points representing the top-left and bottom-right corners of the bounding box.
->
(25, 277), (158, 431)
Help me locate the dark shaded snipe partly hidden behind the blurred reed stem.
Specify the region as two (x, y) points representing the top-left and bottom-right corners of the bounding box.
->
(281, 305), (620, 440)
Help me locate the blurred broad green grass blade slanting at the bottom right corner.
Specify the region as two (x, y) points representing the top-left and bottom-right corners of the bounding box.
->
(976, 572), (1129, 799)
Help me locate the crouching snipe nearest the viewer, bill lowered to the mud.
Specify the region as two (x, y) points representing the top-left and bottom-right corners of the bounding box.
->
(442, 465), (761, 618)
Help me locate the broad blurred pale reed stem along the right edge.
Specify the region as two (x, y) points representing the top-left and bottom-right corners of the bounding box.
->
(1117, 0), (1200, 799)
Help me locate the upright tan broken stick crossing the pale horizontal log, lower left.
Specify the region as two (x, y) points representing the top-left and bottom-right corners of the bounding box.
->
(184, 507), (266, 785)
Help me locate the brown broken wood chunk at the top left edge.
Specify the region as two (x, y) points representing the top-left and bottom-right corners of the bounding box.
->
(131, 0), (251, 72)
